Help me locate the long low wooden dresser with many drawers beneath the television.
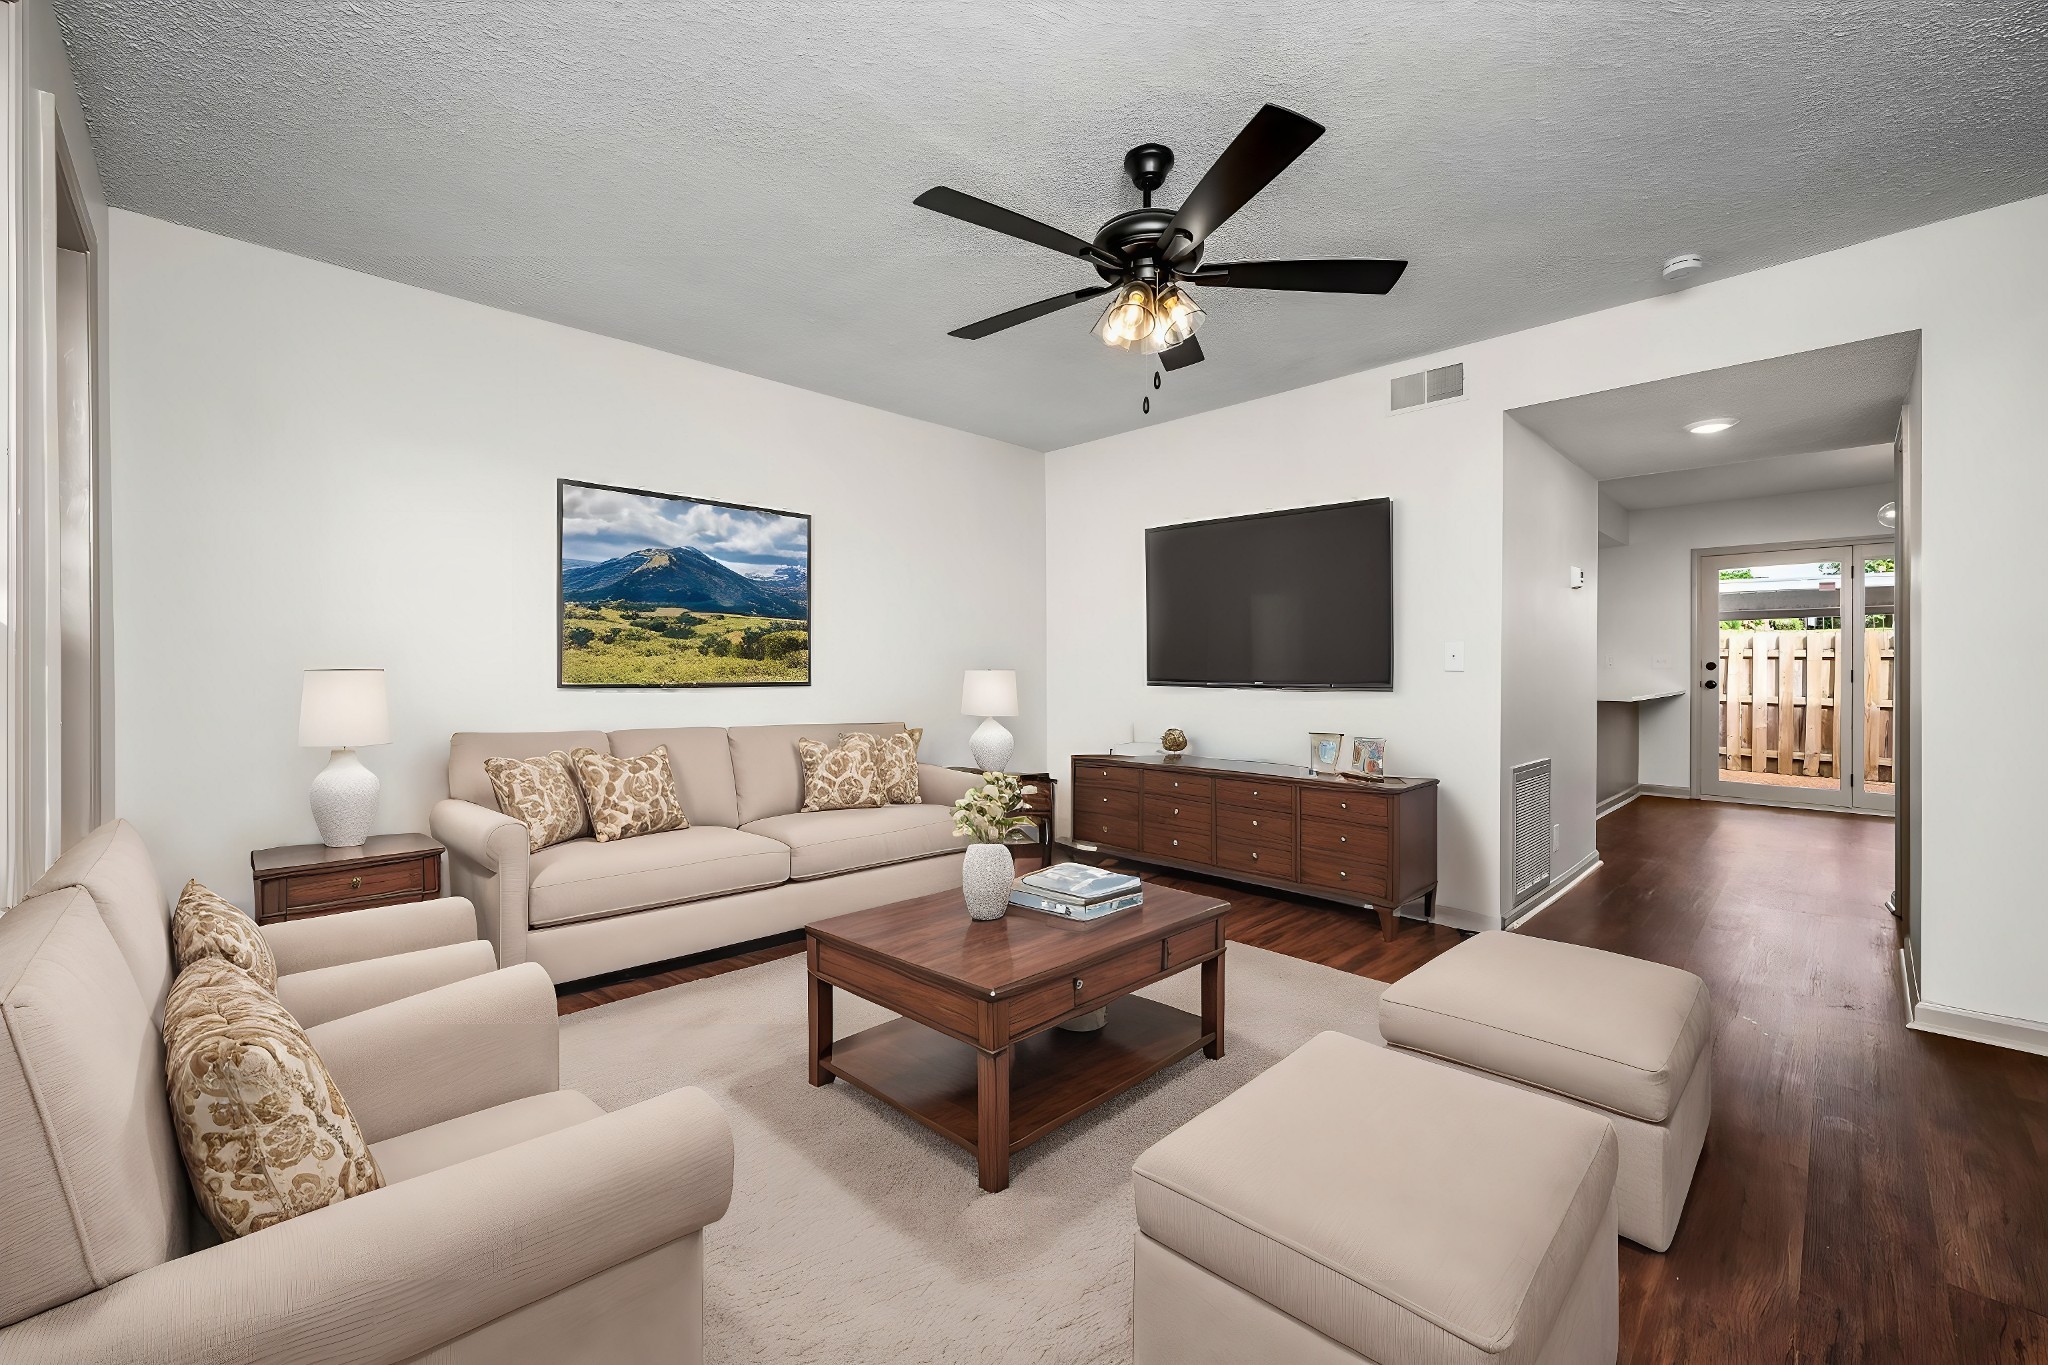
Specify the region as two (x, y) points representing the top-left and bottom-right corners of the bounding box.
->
(1073, 755), (1436, 937)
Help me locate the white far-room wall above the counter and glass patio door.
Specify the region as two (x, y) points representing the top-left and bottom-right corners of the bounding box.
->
(1599, 483), (1892, 788)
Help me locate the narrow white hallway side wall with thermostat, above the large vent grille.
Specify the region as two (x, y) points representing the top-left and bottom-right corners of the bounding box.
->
(1499, 417), (1602, 907)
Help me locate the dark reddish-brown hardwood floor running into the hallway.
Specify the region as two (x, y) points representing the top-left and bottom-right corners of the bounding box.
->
(561, 796), (2048, 1365)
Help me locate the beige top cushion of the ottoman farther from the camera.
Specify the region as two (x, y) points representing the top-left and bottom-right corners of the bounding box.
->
(1380, 929), (1714, 1124)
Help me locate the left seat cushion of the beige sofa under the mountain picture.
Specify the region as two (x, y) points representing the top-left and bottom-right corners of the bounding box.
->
(528, 825), (788, 929)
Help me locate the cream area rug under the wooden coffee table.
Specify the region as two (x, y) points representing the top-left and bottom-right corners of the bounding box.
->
(561, 943), (1384, 1365)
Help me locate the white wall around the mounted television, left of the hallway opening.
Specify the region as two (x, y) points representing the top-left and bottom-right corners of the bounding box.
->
(1047, 378), (1501, 927)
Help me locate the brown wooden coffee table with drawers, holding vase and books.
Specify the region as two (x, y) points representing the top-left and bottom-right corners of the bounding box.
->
(805, 884), (1231, 1193)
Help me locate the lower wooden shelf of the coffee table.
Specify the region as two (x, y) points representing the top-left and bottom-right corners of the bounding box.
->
(819, 995), (1217, 1178)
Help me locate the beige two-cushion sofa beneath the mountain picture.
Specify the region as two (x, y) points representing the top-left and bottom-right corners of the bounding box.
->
(432, 722), (977, 982)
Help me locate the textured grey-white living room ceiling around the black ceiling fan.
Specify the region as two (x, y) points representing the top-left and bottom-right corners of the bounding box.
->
(57, 0), (2048, 448)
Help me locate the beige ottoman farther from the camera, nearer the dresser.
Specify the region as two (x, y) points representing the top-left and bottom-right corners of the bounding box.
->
(1380, 933), (1714, 1250)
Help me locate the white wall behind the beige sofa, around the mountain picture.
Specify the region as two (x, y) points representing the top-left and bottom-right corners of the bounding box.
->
(113, 213), (1044, 905)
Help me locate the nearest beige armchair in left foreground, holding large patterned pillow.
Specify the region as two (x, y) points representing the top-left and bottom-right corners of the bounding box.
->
(0, 825), (733, 1365)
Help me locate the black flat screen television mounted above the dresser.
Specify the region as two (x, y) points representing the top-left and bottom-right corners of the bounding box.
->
(1145, 497), (1395, 692)
